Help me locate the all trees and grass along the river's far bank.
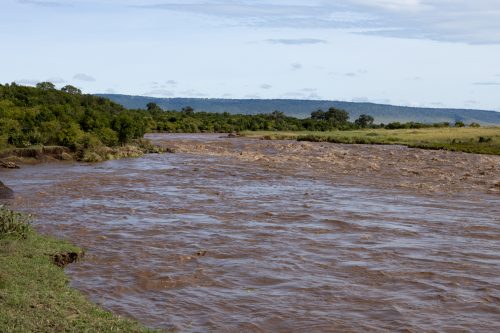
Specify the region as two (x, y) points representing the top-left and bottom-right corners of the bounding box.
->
(0, 82), (500, 162)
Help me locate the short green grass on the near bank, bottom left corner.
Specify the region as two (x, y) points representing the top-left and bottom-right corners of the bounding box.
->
(0, 206), (156, 332)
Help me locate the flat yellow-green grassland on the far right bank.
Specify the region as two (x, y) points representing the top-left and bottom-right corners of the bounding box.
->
(240, 127), (500, 155)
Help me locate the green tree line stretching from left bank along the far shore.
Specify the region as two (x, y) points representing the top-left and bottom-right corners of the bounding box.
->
(0, 82), (476, 151)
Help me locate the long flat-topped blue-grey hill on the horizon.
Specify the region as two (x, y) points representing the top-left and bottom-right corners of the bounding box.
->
(98, 94), (500, 125)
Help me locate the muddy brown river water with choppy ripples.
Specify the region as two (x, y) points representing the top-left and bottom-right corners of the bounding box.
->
(0, 135), (500, 332)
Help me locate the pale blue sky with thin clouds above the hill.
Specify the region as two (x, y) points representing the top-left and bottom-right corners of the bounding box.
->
(0, 0), (500, 111)
